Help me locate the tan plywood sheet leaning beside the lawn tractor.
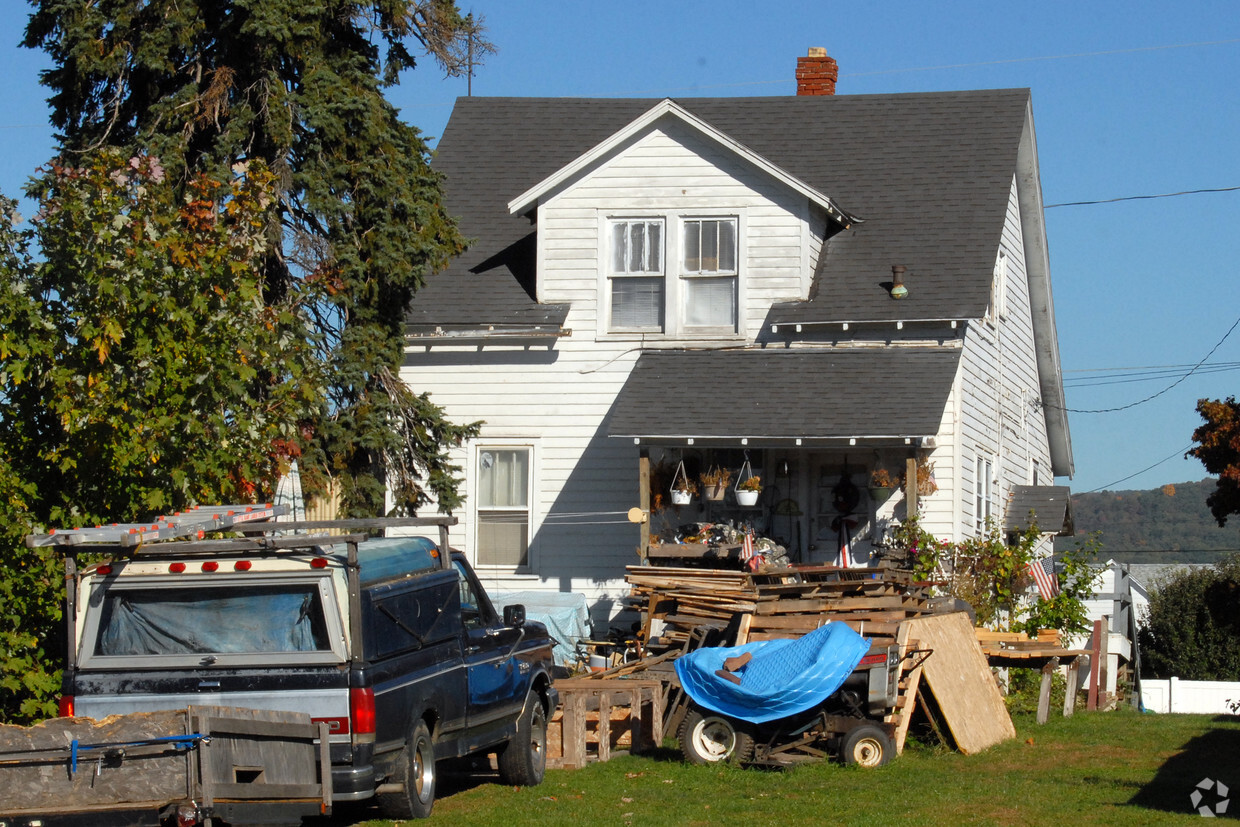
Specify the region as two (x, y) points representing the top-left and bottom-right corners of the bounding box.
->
(904, 611), (1016, 755)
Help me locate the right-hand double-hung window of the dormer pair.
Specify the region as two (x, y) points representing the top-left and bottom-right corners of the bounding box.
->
(681, 218), (738, 332)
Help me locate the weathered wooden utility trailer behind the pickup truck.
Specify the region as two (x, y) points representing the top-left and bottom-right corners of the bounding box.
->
(0, 707), (331, 827)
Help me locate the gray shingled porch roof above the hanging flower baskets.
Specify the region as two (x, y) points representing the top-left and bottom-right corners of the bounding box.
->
(608, 347), (960, 440)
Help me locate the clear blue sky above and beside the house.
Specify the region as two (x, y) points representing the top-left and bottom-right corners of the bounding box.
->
(0, 0), (1240, 491)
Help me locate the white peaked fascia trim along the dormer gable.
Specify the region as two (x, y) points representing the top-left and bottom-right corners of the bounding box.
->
(508, 98), (861, 227)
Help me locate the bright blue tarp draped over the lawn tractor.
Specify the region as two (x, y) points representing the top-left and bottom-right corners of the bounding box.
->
(676, 622), (869, 724)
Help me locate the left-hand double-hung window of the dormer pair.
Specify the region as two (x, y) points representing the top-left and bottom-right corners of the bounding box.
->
(609, 218), (666, 331)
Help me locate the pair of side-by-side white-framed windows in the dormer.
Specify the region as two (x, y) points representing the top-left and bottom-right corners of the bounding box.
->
(604, 213), (740, 337)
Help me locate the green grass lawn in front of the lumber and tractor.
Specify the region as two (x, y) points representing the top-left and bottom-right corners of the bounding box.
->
(336, 710), (1240, 827)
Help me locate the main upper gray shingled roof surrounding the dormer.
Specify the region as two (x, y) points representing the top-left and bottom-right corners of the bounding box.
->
(409, 89), (1029, 330)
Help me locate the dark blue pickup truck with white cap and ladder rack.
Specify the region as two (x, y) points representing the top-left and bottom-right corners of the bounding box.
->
(29, 506), (557, 818)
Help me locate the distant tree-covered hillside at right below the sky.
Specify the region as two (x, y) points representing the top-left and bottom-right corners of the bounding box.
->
(1055, 479), (1240, 563)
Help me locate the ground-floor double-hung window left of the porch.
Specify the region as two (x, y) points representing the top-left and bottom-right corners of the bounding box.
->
(476, 446), (532, 569)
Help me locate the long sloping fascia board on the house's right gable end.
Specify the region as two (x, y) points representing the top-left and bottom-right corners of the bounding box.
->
(1016, 100), (1075, 477)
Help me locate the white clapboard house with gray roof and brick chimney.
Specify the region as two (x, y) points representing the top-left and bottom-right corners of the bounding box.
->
(403, 52), (1073, 614)
